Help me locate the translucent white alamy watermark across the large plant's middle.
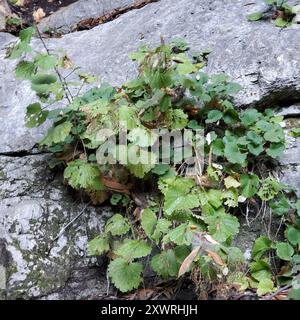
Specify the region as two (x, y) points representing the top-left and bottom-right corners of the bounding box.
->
(96, 122), (205, 175)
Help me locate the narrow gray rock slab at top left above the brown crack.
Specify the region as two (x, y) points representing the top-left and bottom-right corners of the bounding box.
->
(39, 0), (155, 34)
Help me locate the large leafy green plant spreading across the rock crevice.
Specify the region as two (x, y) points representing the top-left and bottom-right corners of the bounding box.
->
(9, 28), (298, 294)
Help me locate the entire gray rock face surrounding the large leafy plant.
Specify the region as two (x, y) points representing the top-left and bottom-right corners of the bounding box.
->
(0, 0), (300, 299)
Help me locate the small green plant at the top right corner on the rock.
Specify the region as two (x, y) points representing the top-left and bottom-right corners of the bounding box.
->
(247, 0), (297, 28)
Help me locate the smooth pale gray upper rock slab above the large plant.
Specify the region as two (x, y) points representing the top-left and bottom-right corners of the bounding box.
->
(0, 0), (300, 152)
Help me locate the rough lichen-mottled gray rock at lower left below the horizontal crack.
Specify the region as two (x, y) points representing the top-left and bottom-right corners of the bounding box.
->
(0, 155), (111, 299)
